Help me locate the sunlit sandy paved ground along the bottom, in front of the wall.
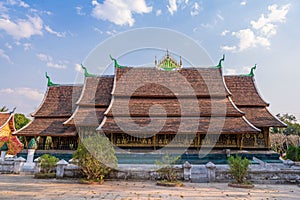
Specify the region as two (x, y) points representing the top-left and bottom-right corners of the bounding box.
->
(0, 175), (300, 200)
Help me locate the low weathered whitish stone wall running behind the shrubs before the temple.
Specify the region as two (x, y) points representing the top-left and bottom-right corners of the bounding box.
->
(0, 153), (300, 184)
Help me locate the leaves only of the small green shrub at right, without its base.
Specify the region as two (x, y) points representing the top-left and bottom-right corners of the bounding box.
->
(228, 155), (250, 184)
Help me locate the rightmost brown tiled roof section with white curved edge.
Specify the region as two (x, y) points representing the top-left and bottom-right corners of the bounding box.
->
(224, 76), (286, 128)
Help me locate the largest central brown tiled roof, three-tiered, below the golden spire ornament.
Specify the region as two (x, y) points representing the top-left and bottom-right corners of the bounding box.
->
(99, 67), (260, 134)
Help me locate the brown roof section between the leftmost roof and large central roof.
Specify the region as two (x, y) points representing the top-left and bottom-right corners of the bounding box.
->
(64, 76), (114, 127)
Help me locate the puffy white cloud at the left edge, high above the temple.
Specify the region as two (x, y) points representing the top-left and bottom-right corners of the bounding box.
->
(0, 16), (43, 40)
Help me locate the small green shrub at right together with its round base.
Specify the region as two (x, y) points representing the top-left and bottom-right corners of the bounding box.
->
(228, 155), (254, 188)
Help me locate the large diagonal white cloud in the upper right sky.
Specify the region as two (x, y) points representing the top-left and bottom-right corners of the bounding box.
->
(222, 4), (290, 51)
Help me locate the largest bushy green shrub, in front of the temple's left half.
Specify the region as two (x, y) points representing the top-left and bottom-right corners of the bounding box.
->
(73, 133), (117, 182)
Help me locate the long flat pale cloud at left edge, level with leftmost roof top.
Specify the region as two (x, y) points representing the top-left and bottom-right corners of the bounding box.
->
(0, 87), (44, 101)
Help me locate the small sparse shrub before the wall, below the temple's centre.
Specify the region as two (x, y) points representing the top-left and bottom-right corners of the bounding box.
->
(155, 153), (180, 182)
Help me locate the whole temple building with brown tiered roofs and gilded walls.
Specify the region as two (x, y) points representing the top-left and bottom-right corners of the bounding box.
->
(16, 52), (286, 154)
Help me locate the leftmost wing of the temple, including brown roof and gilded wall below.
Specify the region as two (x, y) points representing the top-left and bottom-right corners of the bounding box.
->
(15, 74), (82, 150)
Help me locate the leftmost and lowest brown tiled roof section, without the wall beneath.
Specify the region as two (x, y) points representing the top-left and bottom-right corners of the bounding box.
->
(15, 85), (82, 137)
